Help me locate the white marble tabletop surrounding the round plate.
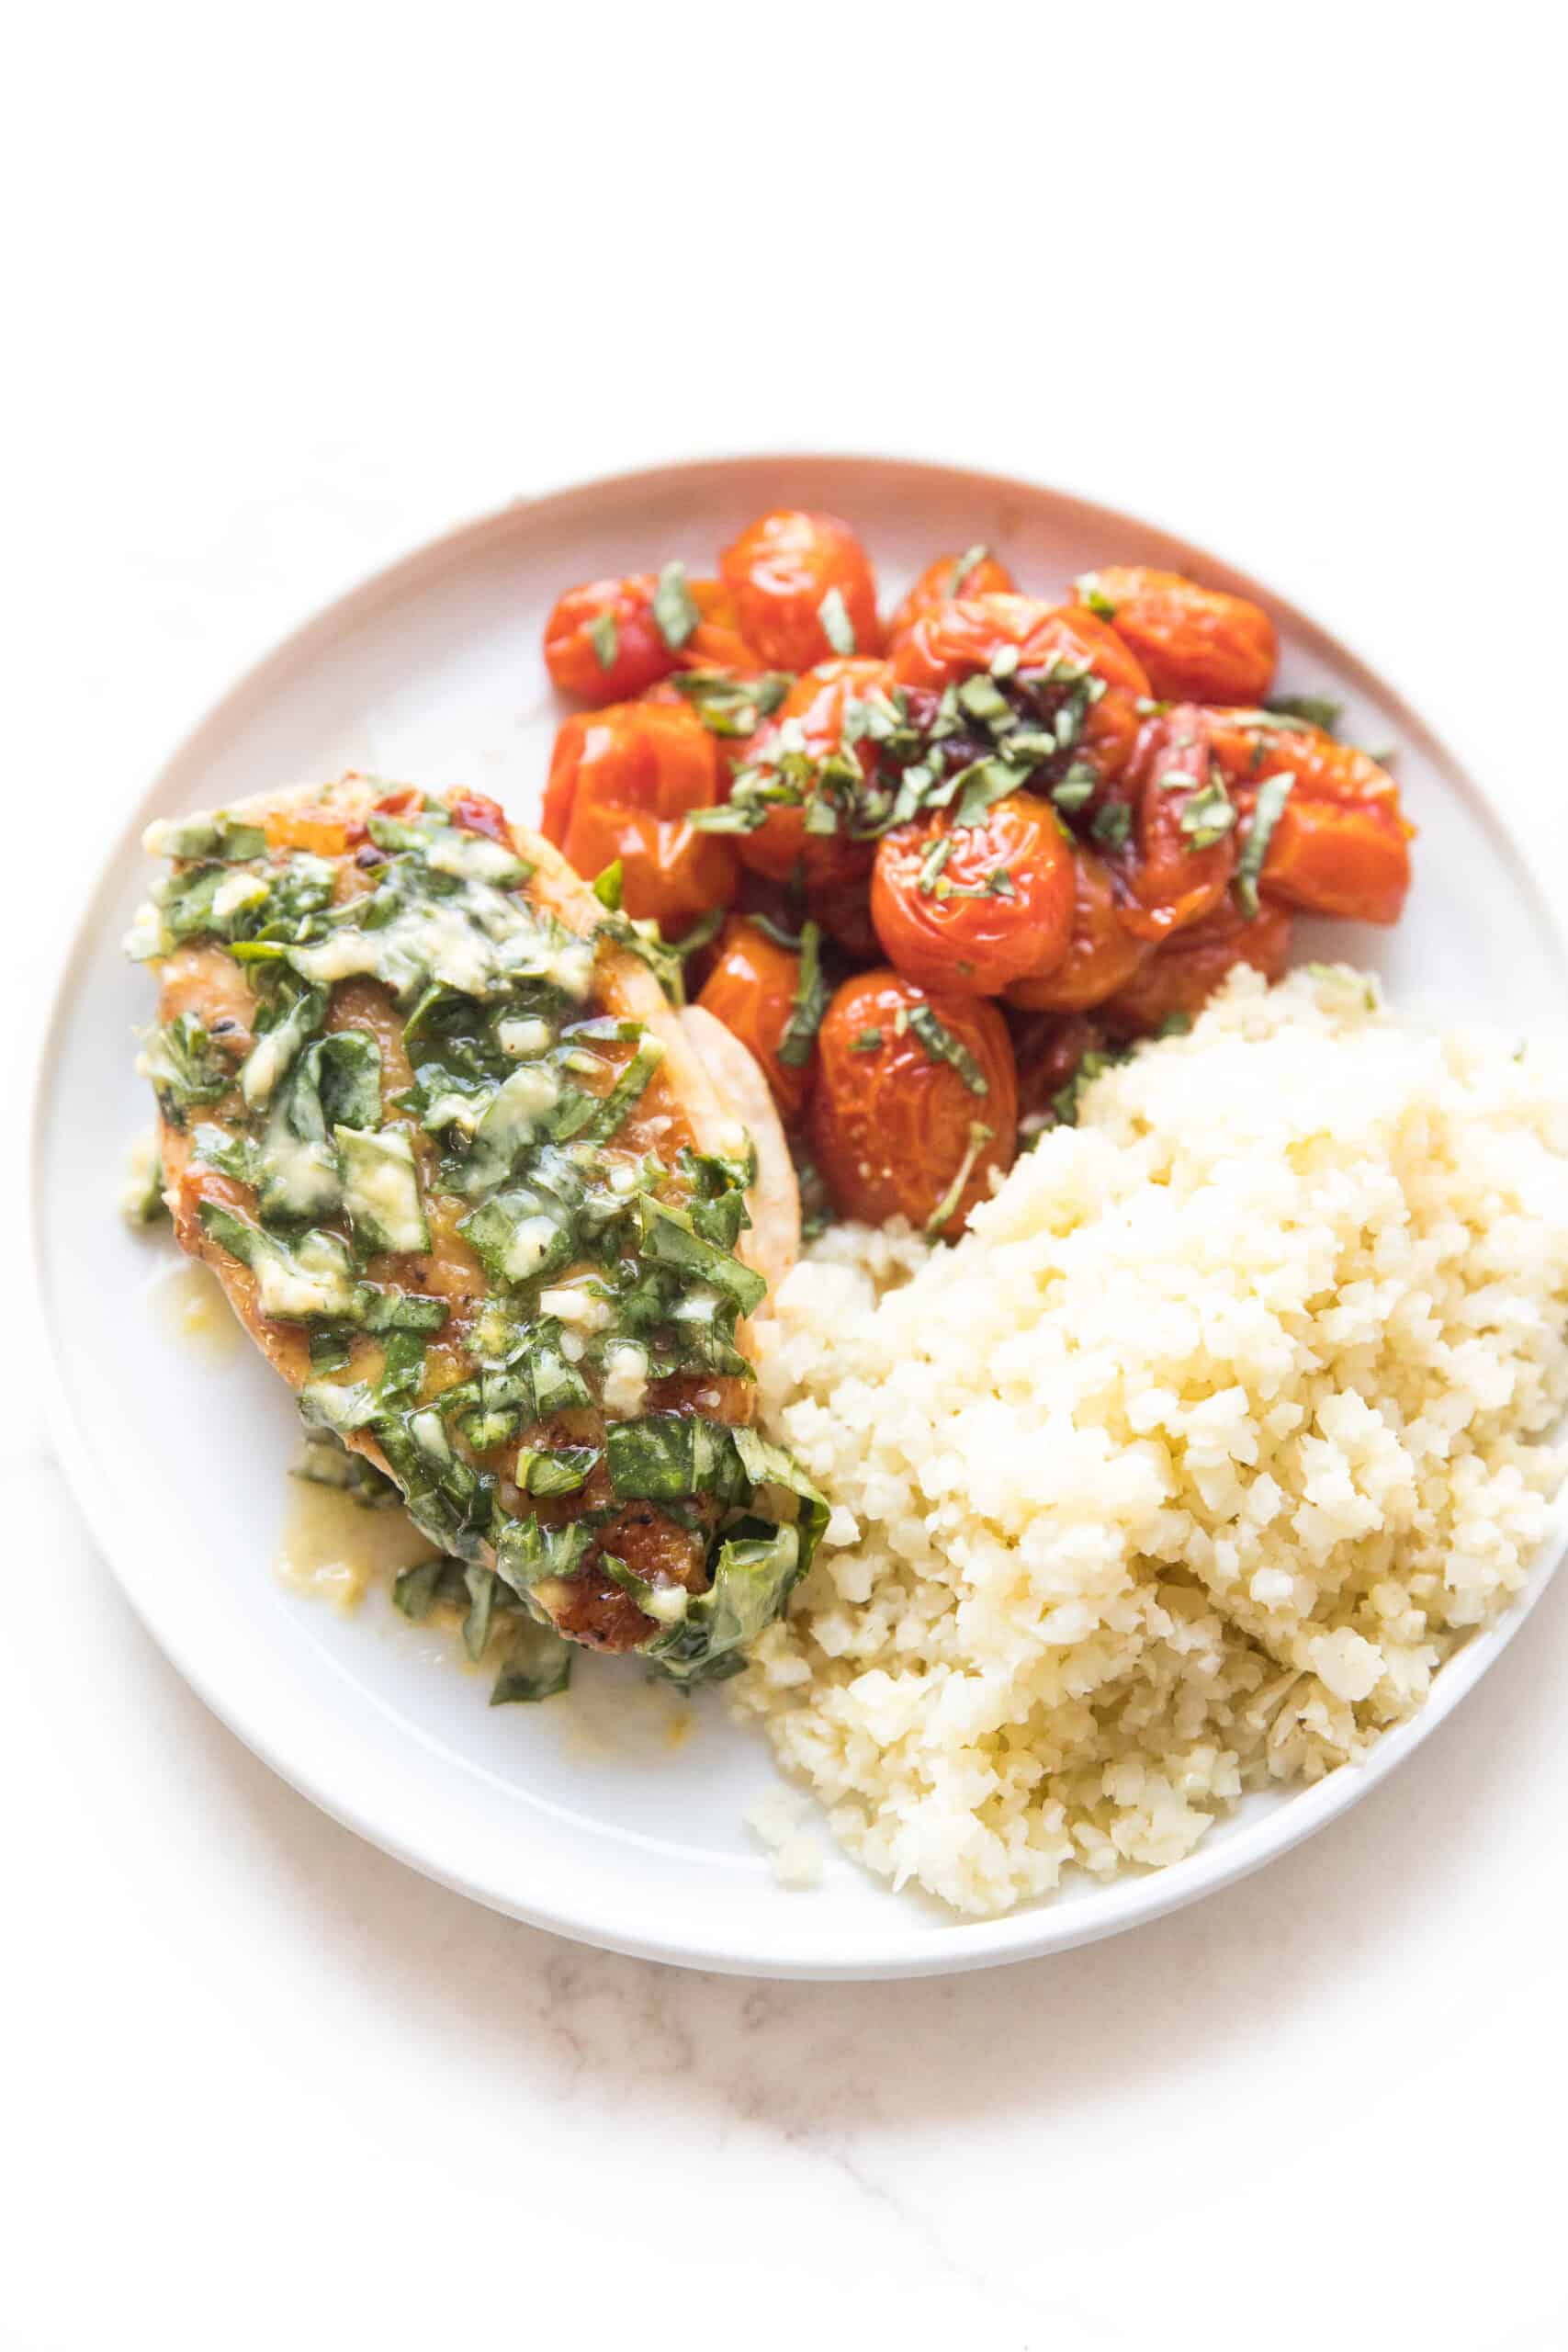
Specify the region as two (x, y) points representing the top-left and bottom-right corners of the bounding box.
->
(12, 5), (1568, 2352)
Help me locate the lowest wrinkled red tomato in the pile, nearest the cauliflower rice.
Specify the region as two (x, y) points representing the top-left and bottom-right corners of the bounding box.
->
(811, 971), (1018, 1239)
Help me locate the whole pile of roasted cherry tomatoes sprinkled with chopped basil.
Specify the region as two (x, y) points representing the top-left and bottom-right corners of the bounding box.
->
(543, 508), (1411, 1235)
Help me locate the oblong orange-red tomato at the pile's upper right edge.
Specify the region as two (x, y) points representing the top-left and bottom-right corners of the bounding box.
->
(1075, 564), (1279, 703)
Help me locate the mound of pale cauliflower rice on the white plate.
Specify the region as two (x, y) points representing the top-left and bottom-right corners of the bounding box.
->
(733, 967), (1568, 1917)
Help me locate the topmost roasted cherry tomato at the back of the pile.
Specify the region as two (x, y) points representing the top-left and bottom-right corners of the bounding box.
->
(719, 505), (882, 671)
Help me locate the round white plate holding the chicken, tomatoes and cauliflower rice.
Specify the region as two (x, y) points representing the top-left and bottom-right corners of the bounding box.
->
(33, 458), (1568, 1975)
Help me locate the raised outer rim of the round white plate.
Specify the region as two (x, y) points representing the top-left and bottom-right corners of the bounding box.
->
(26, 449), (1568, 1983)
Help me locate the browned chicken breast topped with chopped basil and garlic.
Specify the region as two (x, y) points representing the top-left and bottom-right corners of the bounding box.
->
(130, 776), (825, 1696)
